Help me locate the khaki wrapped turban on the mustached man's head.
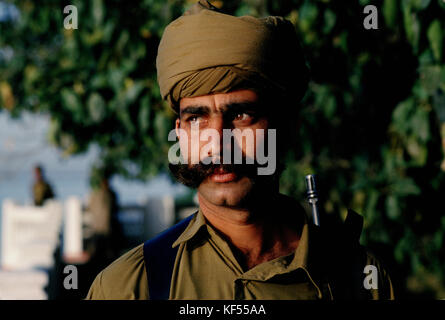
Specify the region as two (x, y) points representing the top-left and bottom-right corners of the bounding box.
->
(156, 1), (308, 110)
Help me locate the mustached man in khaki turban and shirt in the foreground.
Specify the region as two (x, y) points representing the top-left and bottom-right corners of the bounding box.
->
(87, 1), (393, 299)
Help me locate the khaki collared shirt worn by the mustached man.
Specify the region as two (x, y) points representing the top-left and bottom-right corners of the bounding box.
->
(86, 211), (394, 300)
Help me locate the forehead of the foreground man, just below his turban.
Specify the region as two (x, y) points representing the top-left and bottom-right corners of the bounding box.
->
(179, 89), (259, 111)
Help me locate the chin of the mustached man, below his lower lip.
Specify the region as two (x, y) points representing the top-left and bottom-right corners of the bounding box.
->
(198, 177), (254, 208)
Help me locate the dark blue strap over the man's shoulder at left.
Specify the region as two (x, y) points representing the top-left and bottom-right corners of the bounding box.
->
(144, 214), (194, 300)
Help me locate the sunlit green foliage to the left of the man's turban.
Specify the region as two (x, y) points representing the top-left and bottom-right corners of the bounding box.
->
(0, 0), (182, 178)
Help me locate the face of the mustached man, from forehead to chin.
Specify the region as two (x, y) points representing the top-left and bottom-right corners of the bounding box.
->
(176, 90), (270, 207)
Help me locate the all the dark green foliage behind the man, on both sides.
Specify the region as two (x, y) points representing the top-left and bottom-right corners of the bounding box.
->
(0, 0), (445, 298)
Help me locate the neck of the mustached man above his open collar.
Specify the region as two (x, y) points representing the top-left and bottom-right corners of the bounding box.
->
(198, 193), (299, 269)
